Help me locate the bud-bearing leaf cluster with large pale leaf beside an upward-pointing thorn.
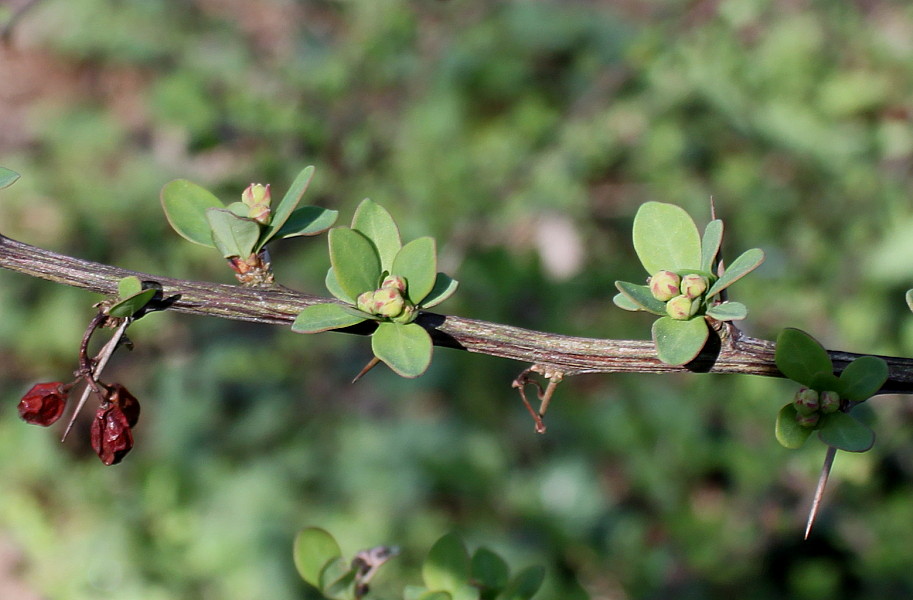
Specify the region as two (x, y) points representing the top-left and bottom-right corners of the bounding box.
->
(614, 202), (764, 365)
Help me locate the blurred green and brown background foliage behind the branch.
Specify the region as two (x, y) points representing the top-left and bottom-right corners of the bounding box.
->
(0, 0), (913, 600)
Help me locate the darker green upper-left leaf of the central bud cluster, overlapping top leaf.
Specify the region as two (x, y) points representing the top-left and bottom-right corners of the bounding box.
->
(329, 227), (380, 304)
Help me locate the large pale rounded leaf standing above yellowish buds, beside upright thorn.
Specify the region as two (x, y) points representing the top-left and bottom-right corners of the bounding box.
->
(634, 202), (701, 275)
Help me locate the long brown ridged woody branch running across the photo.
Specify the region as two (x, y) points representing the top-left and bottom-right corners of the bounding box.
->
(0, 235), (913, 393)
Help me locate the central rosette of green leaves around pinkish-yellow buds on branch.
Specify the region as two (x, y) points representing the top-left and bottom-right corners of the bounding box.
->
(292, 199), (457, 377)
